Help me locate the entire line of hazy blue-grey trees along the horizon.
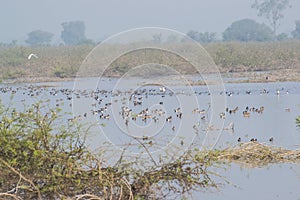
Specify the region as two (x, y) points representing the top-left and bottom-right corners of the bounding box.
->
(9, 0), (300, 46)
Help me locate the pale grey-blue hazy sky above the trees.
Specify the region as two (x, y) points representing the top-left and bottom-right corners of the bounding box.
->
(0, 0), (300, 43)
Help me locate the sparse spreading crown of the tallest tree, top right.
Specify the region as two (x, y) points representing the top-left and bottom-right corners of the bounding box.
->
(251, 0), (291, 35)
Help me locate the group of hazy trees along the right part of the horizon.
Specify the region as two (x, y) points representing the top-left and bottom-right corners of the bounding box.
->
(187, 0), (300, 43)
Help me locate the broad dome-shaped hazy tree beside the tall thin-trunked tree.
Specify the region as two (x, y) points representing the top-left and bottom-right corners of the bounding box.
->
(223, 19), (274, 42)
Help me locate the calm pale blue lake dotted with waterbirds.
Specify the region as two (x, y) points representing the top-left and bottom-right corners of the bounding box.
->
(0, 78), (300, 200)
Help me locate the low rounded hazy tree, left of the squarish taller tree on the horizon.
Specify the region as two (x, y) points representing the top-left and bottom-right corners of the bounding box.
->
(25, 30), (54, 45)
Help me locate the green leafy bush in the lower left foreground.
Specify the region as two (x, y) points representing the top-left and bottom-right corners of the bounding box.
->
(0, 103), (89, 199)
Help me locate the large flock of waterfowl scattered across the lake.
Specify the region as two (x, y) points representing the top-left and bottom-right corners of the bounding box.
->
(0, 85), (289, 145)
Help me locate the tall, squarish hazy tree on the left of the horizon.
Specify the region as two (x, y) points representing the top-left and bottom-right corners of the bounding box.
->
(61, 21), (87, 45)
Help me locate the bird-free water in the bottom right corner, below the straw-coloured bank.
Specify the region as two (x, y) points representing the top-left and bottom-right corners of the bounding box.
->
(195, 164), (300, 200)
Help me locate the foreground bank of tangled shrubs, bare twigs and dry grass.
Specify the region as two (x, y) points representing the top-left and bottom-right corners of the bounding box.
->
(0, 102), (300, 199)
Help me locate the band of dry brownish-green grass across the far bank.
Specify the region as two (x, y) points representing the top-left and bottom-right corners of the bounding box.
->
(0, 40), (300, 79)
